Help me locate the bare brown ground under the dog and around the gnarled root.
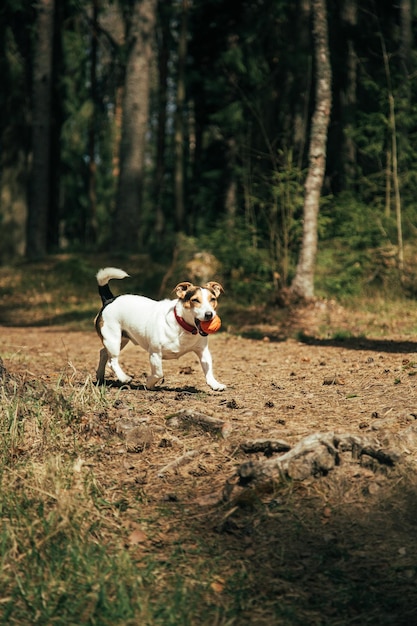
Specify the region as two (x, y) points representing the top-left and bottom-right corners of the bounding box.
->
(0, 305), (417, 626)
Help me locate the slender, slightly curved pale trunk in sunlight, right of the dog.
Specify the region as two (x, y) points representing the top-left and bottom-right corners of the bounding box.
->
(291, 0), (332, 299)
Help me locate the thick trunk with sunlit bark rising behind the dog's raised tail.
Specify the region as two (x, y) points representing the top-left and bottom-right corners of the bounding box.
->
(113, 0), (156, 252)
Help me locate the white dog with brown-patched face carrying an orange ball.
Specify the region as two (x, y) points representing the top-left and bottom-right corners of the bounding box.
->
(95, 267), (226, 391)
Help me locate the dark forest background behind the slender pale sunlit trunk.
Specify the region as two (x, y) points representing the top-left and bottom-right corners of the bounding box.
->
(0, 0), (417, 301)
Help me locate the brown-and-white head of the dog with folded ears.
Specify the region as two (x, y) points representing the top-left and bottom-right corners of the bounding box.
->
(174, 281), (224, 322)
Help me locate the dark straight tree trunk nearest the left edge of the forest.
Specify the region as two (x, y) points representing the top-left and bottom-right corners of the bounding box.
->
(26, 0), (54, 259)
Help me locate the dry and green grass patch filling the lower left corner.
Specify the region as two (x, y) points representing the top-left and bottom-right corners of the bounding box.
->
(0, 372), (244, 626)
